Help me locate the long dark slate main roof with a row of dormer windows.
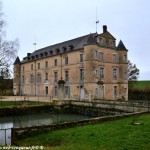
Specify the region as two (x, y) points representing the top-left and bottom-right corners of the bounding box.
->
(21, 33), (97, 63)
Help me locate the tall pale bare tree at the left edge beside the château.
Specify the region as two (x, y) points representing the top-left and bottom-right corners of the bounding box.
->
(0, 1), (19, 79)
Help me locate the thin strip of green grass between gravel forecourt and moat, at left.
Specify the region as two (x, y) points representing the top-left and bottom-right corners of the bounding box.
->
(0, 100), (46, 108)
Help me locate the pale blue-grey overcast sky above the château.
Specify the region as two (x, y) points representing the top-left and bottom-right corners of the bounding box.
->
(1, 0), (150, 80)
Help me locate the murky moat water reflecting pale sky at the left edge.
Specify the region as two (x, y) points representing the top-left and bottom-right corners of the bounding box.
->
(0, 113), (89, 145)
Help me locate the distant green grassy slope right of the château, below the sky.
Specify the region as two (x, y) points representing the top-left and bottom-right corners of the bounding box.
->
(131, 81), (150, 90)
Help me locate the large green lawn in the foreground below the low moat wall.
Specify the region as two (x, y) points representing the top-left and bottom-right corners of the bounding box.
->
(17, 114), (150, 150)
